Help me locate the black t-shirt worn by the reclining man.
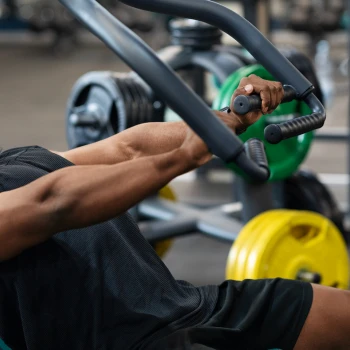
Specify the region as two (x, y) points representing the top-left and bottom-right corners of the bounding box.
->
(0, 146), (218, 350)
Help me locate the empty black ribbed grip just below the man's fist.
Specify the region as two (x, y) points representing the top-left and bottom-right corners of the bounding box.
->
(265, 113), (325, 144)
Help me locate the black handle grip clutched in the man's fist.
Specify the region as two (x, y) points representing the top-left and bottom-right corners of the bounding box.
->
(233, 85), (297, 115)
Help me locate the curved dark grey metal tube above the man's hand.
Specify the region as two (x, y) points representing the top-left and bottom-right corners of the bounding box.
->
(122, 0), (312, 97)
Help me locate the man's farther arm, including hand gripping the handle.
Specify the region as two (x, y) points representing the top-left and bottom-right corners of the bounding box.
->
(56, 75), (283, 165)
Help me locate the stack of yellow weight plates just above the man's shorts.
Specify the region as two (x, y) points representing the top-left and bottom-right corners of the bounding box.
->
(226, 210), (349, 289)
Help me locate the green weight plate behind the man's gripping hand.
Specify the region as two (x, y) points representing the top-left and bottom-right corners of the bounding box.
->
(213, 65), (314, 181)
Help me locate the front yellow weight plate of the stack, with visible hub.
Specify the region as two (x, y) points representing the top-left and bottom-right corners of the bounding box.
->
(252, 211), (349, 288)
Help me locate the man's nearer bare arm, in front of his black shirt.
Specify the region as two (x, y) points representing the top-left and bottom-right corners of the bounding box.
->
(0, 148), (194, 261)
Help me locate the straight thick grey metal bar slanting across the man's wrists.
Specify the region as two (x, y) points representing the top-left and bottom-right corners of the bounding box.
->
(60, 0), (242, 162)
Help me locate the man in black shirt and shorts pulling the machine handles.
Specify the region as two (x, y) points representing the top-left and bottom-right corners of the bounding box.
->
(0, 76), (350, 350)
